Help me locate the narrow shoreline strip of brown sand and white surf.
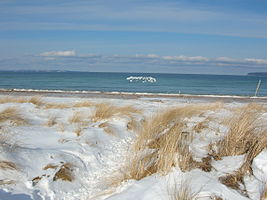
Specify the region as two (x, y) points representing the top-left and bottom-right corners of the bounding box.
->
(0, 89), (267, 102)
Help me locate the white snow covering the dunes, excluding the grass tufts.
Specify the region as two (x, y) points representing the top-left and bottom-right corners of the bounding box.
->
(0, 97), (267, 200)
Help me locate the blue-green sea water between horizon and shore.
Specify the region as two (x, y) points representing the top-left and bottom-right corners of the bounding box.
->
(0, 72), (267, 96)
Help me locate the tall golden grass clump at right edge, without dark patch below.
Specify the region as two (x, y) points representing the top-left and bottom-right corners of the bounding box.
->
(216, 104), (267, 173)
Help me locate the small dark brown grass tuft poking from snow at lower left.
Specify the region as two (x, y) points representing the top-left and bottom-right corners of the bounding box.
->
(53, 163), (74, 182)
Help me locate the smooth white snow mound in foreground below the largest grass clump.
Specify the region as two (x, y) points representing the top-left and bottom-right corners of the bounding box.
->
(108, 169), (248, 200)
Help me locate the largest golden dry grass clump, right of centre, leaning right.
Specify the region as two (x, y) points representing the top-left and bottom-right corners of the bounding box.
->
(120, 103), (222, 180)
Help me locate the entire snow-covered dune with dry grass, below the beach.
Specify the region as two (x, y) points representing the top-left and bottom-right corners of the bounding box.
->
(0, 96), (267, 200)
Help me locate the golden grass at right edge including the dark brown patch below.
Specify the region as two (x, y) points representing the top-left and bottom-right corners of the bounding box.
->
(215, 103), (267, 196)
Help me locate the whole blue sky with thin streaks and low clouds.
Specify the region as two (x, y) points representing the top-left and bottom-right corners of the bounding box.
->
(0, 0), (267, 75)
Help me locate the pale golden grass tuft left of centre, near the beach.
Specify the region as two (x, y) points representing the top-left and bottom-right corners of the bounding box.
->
(92, 103), (141, 122)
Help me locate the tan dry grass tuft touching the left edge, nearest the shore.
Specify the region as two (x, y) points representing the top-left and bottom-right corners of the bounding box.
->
(0, 107), (26, 126)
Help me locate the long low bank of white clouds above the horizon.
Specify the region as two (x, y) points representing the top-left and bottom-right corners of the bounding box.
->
(39, 50), (267, 67)
